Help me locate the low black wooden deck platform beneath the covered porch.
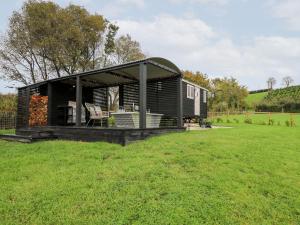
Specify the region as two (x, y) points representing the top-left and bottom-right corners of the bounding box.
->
(16, 126), (186, 146)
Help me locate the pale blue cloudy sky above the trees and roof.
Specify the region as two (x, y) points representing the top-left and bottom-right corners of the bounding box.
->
(0, 0), (300, 93)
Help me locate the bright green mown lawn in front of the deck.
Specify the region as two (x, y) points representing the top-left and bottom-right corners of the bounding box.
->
(0, 123), (300, 225)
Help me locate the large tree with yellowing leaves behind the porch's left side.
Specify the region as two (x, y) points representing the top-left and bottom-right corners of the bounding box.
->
(0, 0), (118, 85)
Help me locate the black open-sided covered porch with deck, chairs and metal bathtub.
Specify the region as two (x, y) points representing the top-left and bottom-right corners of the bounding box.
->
(16, 58), (184, 144)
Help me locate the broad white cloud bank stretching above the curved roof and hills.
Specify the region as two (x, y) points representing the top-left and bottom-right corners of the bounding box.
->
(118, 15), (300, 89)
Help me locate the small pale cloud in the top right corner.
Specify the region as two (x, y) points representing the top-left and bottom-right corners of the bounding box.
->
(272, 0), (300, 30)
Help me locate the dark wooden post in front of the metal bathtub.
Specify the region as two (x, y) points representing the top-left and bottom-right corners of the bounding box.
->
(139, 62), (147, 129)
